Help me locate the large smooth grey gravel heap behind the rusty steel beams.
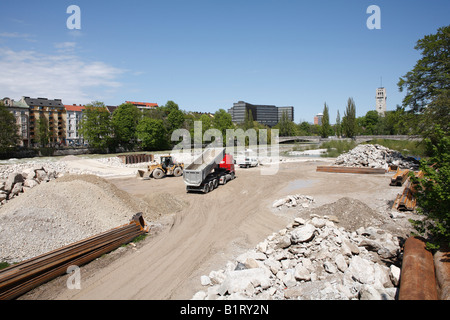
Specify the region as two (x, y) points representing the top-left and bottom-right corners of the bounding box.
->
(0, 175), (139, 263)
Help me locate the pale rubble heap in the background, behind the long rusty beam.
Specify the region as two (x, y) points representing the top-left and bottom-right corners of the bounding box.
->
(335, 144), (418, 170)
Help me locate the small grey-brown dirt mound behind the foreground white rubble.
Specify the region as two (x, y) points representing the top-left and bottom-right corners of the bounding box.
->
(308, 197), (381, 231)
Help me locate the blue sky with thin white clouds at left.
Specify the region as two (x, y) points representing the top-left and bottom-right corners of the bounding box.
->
(0, 0), (450, 123)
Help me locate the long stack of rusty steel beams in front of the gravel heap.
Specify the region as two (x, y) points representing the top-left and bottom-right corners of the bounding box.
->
(0, 213), (149, 300)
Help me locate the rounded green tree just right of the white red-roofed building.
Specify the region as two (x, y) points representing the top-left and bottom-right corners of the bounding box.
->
(79, 101), (114, 152)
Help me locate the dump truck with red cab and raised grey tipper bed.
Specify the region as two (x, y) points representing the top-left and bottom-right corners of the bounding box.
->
(183, 148), (236, 193)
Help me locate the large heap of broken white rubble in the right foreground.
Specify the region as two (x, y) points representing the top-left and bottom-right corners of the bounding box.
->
(193, 214), (400, 300)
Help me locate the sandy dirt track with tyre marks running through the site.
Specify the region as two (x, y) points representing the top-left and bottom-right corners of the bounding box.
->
(36, 161), (398, 299)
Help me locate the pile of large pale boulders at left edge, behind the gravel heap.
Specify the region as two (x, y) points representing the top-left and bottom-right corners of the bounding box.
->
(0, 166), (61, 206)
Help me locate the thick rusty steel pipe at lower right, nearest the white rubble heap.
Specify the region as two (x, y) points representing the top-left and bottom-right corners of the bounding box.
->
(399, 237), (438, 300)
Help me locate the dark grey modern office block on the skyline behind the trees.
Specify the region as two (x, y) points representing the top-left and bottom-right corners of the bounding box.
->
(228, 101), (294, 127)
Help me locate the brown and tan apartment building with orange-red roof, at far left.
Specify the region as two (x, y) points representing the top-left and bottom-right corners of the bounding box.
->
(22, 97), (67, 146)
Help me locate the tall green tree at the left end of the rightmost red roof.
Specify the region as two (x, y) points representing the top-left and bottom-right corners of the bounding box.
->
(111, 103), (142, 150)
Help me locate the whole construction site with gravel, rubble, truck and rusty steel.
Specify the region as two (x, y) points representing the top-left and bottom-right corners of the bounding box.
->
(0, 145), (450, 300)
